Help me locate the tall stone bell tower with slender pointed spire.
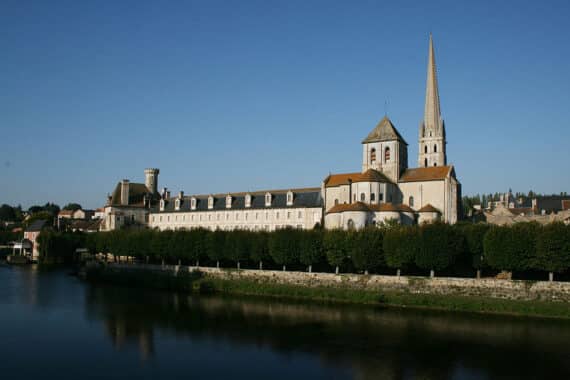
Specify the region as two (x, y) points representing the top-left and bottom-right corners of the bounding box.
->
(418, 34), (447, 168)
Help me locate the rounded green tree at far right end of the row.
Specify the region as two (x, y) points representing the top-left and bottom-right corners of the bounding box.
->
(536, 223), (570, 281)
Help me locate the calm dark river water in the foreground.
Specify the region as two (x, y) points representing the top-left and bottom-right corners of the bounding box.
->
(0, 266), (570, 380)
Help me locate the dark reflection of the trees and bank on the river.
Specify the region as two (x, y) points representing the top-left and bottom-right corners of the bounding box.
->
(86, 286), (570, 379)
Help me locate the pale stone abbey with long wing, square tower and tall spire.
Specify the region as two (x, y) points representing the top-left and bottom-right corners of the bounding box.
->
(102, 36), (461, 231)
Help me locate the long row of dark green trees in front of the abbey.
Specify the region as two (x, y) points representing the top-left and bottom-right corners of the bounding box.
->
(40, 223), (570, 279)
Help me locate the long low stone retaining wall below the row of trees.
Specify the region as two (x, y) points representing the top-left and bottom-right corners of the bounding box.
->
(104, 264), (570, 302)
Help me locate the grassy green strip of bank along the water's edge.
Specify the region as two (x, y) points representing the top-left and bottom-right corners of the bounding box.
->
(83, 269), (570, 319)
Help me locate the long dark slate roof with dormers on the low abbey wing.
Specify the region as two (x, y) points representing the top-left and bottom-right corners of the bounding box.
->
(153, 187), (323, 212)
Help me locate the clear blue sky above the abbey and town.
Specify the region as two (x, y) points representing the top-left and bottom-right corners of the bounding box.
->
(0, 0), (570, 208)
